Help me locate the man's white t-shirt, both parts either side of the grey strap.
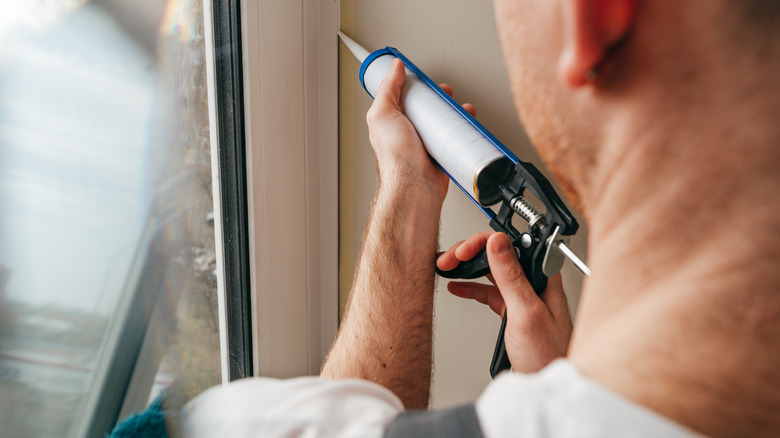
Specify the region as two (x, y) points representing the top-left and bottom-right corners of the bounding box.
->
(184, 359), (698, 438)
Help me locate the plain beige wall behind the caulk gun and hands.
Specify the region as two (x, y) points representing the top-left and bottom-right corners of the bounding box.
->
(339, 0), (585, 407)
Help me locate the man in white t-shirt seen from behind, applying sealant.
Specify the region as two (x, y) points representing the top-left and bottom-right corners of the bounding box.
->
(184, 0), (780, 437)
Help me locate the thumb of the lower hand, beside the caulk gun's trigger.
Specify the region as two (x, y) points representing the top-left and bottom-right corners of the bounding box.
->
(487, 233), (541, 317)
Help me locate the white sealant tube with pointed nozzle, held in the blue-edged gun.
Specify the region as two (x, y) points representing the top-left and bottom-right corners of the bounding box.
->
(339, 32), (516, 207)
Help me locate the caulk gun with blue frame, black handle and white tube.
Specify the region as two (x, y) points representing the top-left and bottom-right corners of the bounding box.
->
(339, 32), (590, 377)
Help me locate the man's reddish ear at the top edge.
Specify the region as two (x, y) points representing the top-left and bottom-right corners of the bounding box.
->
(558, 0), (637, 87)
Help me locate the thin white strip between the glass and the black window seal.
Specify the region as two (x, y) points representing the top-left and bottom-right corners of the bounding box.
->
(203, 0), (230, 384)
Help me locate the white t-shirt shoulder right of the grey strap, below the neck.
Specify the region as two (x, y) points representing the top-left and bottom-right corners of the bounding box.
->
(476, 359), (697, 438)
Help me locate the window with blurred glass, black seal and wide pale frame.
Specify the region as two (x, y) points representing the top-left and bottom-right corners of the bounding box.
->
(0, 0), (338, 437)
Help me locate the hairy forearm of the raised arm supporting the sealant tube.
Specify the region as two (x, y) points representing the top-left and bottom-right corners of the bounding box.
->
(322, 176), (441, 408)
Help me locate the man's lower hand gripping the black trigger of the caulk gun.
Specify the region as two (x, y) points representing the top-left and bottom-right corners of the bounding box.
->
(436, 231), (572, 373)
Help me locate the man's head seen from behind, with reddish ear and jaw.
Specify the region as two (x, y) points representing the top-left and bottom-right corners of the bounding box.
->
(495, 0), (780, 216)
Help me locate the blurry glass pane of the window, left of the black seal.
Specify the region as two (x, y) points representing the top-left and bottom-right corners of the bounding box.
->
(0, 0), (221, 437)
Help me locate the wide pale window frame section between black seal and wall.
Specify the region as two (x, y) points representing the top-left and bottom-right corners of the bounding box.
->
(241, 0), (338, 377)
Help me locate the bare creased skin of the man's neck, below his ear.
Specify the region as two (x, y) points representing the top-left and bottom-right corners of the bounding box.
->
(570, 97), (780, 436)
